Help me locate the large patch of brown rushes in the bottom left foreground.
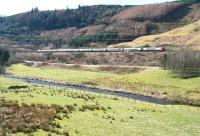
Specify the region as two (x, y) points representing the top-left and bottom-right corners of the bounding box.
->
(0, 99), (73, 135)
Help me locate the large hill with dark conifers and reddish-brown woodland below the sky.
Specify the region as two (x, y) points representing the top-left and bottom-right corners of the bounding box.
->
(0, 2), (200, 48)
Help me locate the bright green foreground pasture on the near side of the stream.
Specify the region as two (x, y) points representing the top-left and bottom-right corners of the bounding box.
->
(0, 77), (200, 136)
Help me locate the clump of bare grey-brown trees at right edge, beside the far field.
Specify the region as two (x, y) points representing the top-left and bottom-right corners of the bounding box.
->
(162, 49), (200, 78)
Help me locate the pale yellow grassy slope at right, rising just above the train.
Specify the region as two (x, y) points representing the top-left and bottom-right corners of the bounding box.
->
(110, 20), (200, 49)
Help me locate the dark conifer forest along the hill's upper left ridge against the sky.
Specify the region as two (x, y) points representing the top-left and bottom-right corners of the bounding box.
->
(0, 5), (124, 32)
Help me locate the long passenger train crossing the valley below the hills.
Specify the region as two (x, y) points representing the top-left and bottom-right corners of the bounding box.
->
(38, 47), (165, 52)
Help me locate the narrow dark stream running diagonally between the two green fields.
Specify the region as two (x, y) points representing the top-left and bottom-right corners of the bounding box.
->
(4, 75), (173, 105)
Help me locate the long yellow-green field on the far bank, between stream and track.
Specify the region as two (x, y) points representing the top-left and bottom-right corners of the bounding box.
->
(8, 64), (200, 105)
